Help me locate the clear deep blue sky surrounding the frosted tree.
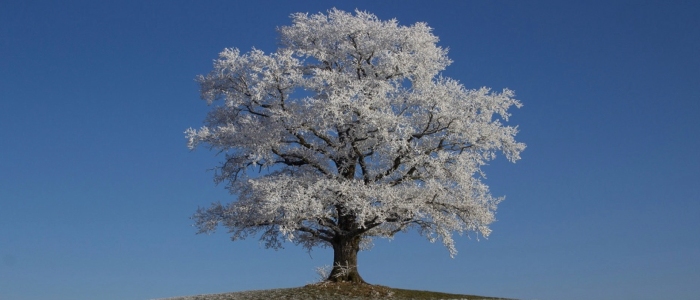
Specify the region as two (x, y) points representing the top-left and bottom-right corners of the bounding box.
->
(0, 0), (700, 300)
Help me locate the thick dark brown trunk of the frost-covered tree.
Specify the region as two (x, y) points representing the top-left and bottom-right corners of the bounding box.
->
(327, 235), (365, 283)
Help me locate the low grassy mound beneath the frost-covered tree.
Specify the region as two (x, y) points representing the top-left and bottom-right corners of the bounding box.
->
(160, 282), (514, 300)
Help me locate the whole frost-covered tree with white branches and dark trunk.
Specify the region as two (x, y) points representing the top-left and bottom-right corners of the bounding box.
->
(186, 9), (525, 282)
